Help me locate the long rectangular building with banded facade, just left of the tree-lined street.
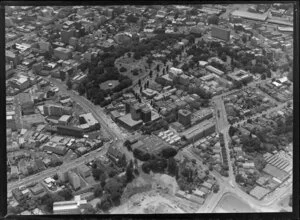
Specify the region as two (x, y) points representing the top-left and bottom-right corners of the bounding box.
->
(180, 120), (216, 143)
